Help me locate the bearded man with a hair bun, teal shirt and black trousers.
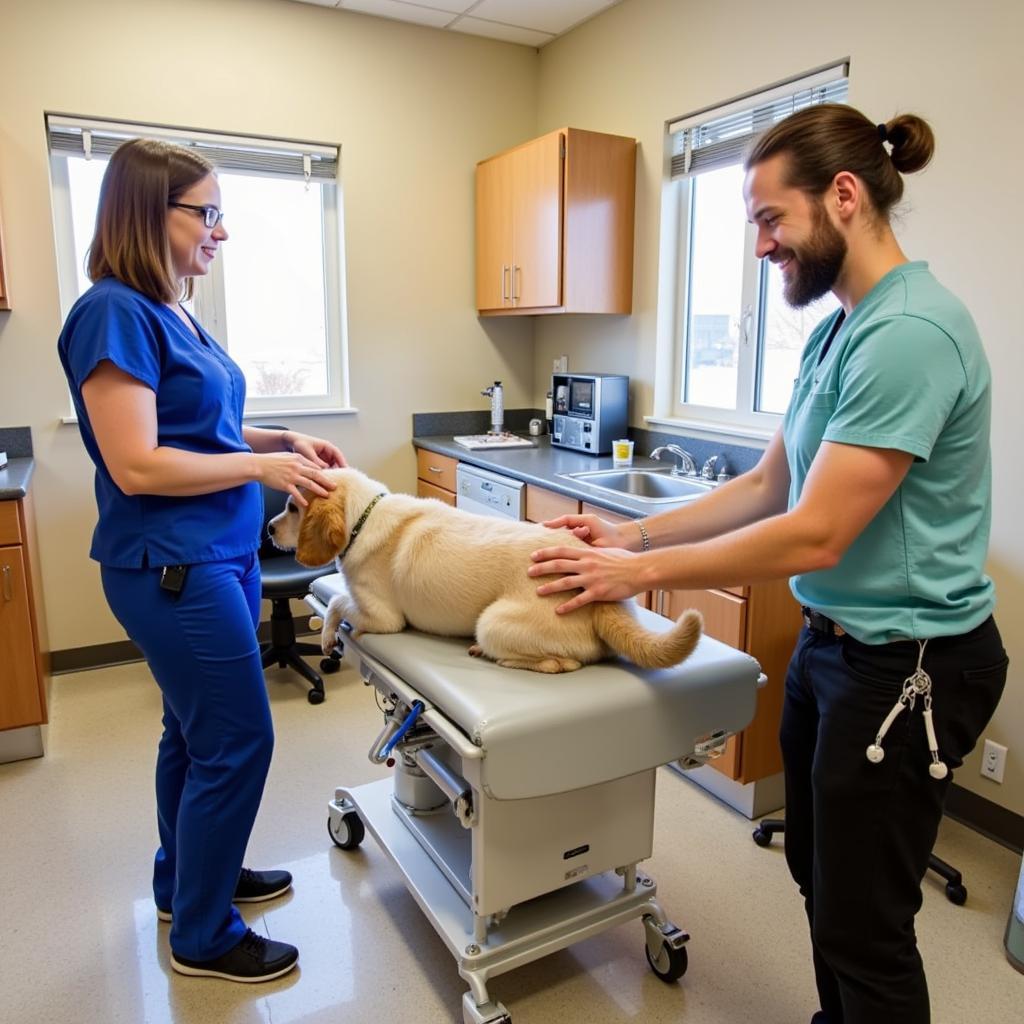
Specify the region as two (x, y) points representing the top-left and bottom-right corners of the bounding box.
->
(528, 104), (1007, 1024)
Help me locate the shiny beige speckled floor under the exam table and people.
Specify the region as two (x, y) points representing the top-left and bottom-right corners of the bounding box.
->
(0, 665), (1024, 1024)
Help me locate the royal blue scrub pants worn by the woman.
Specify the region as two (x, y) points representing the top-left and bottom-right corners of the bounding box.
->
(101, 553), (273, 959)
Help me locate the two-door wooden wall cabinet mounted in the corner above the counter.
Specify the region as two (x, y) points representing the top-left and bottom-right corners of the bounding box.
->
(476, 128), (636, 316)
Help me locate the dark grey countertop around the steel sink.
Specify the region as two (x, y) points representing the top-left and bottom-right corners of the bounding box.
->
(413, 434), (708, 519)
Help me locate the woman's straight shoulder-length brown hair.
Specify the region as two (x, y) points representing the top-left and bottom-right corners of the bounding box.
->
(88, 138), (213, 302)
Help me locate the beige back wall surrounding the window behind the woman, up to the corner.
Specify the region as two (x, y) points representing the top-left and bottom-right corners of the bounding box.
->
(0, 0), (538, 650)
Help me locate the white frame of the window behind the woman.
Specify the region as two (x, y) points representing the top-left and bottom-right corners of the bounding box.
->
(47, 114), (357, 423)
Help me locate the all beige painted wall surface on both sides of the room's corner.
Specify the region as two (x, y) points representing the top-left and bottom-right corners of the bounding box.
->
(0, 0), (1024, 813)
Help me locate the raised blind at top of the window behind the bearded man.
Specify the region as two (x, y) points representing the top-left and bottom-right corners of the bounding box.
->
(667, 60), (850, 178)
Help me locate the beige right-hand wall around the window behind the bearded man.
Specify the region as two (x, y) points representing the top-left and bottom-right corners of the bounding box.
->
(535, 0), (1024, 813)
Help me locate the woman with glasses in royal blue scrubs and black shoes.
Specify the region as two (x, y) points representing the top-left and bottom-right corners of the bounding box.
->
(58, 139), (345, 982)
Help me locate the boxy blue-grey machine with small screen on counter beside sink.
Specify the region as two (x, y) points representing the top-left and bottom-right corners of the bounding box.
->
(551, 374), (630, 455)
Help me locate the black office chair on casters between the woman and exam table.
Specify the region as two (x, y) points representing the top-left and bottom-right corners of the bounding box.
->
(259, 424), (339, 705)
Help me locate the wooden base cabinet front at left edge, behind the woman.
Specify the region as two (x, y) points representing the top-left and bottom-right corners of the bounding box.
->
(0, 498), (49, 737)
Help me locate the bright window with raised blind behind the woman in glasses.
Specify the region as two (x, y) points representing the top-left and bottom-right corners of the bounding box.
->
(47, 115), (349, 416)
